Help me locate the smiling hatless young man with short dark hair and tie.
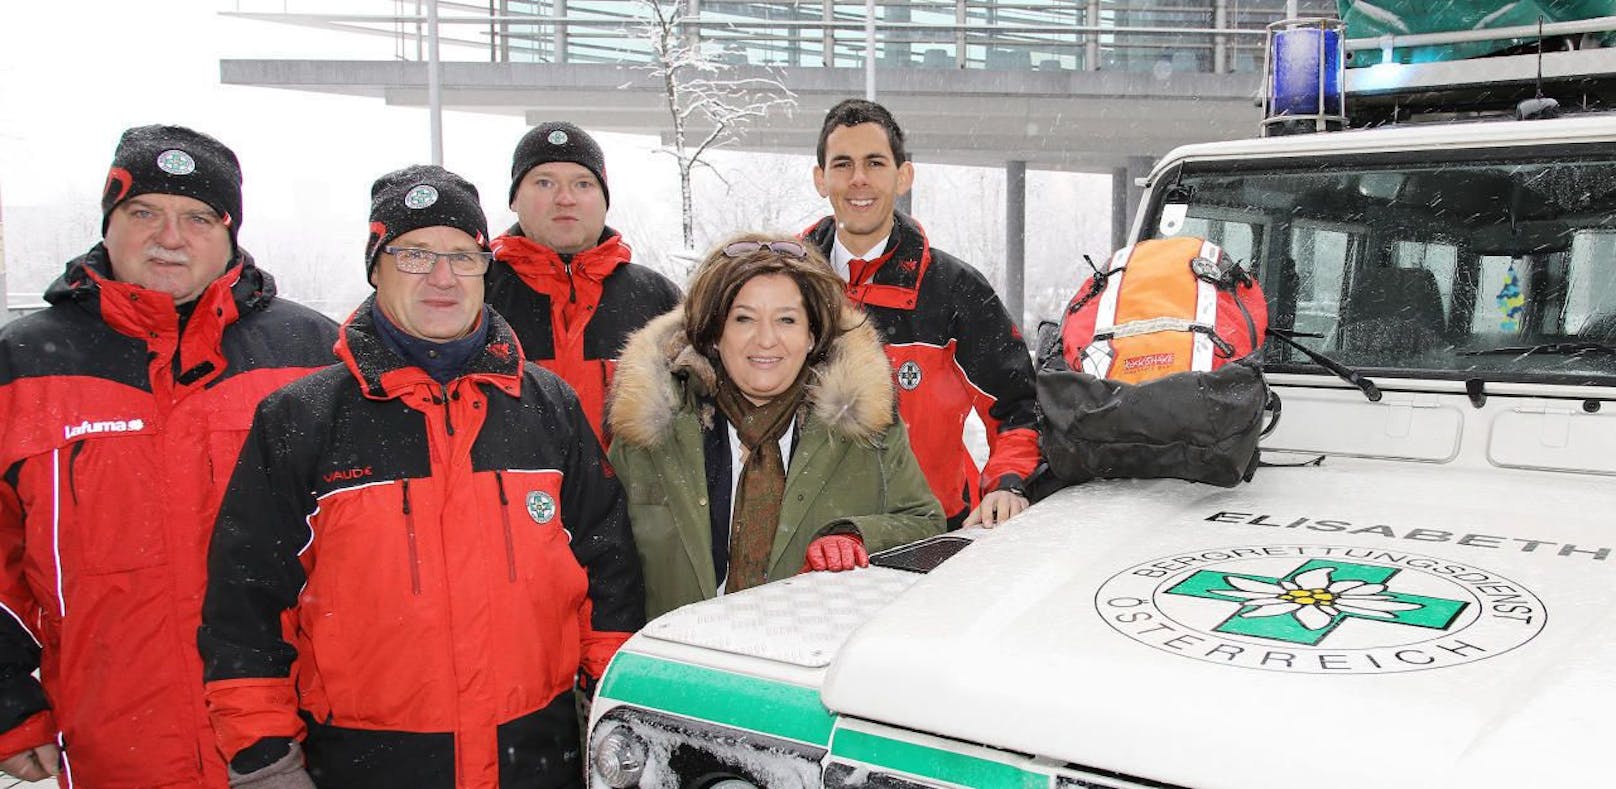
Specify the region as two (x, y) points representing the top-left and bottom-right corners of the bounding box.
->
(803, 99), (1039, 527)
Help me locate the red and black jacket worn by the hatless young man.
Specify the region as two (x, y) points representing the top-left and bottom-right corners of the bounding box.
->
(803, 212), (1039, 527)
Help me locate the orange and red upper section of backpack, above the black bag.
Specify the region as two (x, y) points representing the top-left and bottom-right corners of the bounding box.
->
(1060, 236), (1269, 383)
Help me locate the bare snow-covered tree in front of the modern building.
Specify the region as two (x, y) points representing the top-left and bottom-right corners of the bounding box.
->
(640, 0), (797, 258)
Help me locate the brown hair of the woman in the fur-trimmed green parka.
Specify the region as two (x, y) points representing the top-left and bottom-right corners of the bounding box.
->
(684, 233), (861, 364)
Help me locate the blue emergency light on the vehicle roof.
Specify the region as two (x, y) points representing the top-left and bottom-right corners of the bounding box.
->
(1262, 19), (1346, 136)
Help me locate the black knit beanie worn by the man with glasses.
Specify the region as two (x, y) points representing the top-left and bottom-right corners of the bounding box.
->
(365, 165), (488, 276)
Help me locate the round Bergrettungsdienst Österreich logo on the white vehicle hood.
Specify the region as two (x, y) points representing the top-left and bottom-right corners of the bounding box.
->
(1094, 545), (1547, 674)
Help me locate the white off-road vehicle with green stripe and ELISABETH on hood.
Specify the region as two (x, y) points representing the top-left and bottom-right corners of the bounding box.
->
(590, 23), (1616, 789)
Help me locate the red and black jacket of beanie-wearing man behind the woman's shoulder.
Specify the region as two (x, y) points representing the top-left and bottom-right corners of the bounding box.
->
(483, 226), (679, 443)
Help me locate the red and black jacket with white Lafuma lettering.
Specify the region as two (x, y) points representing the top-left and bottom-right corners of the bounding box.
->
(0, 246), (336, 789)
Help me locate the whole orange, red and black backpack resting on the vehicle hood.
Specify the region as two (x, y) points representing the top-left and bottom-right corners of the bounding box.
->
(1033, 238), (1278, 495)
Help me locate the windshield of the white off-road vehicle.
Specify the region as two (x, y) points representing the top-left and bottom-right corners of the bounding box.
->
(1146, 146), (1616, 385)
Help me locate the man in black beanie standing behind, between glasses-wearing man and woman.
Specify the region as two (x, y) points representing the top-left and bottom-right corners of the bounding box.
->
(488, 121), (679, 441)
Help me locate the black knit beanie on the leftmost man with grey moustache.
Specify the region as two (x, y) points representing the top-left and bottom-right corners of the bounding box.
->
(102, 126), (241, 246)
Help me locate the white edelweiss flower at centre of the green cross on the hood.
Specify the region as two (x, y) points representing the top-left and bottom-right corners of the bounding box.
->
(1217, 567), (1420, 631)
